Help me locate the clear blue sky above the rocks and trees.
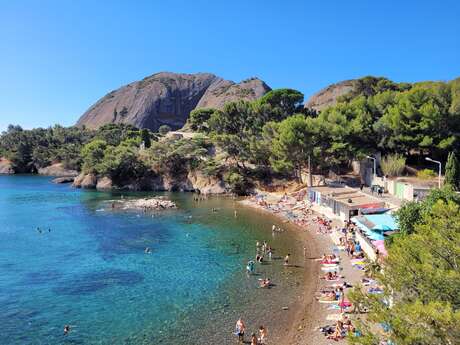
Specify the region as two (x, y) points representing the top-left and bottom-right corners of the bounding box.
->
(0, 0), (460, 131)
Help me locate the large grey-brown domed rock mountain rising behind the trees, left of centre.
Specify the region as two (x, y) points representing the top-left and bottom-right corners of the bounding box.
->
(77, 72), (270, 130)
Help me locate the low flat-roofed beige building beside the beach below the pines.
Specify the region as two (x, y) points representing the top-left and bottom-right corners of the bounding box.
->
(308, 185), (388, 221)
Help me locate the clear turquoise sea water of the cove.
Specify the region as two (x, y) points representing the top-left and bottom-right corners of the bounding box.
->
(0, 176), (303, 345)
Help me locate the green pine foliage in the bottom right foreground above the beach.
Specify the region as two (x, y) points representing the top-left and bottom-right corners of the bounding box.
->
(350, 187), (460, 345)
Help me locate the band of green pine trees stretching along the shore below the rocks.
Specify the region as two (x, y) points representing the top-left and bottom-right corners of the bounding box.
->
(0, 77), (460, 190)
